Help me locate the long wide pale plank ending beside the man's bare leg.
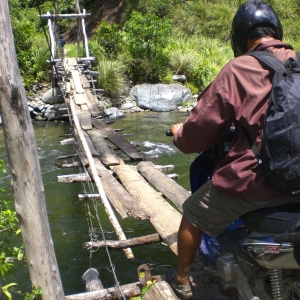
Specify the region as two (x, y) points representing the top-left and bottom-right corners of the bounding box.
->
(111, 165), (181, 255)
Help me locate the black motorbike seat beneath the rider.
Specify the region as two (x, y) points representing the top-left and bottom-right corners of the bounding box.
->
(240, 203), (300, 235)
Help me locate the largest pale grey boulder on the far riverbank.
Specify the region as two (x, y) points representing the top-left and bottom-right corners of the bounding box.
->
(130, 83), (193, 112)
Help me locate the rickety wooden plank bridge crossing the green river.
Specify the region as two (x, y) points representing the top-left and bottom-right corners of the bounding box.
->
(52, 58), (226, 300)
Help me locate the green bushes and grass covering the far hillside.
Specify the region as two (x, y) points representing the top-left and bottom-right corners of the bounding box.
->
(9, 0), (300, 95)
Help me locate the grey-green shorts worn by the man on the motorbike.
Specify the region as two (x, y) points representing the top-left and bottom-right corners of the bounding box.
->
(182, 181), (300, 236)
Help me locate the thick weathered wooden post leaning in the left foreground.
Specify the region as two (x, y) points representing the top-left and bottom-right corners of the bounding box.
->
(0, 0), (64, 300)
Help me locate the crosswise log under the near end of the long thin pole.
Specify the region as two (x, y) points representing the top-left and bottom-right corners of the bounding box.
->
(82, 233), (161, 250)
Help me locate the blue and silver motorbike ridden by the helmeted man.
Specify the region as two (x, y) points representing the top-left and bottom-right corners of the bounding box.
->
(166, 125), (300, 300)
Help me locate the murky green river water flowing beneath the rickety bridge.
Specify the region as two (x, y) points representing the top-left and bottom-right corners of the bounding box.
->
(0, 112), (199, 299)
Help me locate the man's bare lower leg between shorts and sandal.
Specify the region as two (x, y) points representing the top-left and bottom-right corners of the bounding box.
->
(175, 216), (202, 285)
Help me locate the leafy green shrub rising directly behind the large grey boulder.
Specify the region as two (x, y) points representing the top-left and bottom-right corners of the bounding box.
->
(124, 11), (171, 82)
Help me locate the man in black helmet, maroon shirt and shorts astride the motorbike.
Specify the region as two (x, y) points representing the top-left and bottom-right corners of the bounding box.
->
(167, 0), (300, 299)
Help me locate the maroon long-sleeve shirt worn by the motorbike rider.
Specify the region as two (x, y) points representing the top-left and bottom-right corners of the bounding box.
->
(174, 40), (296, 200)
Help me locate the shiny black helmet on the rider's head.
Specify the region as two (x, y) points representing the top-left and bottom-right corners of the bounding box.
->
(231, 0), (283, 57)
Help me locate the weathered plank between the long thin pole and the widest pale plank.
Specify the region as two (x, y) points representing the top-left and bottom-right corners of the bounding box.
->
(94, 159), (149, 220)
